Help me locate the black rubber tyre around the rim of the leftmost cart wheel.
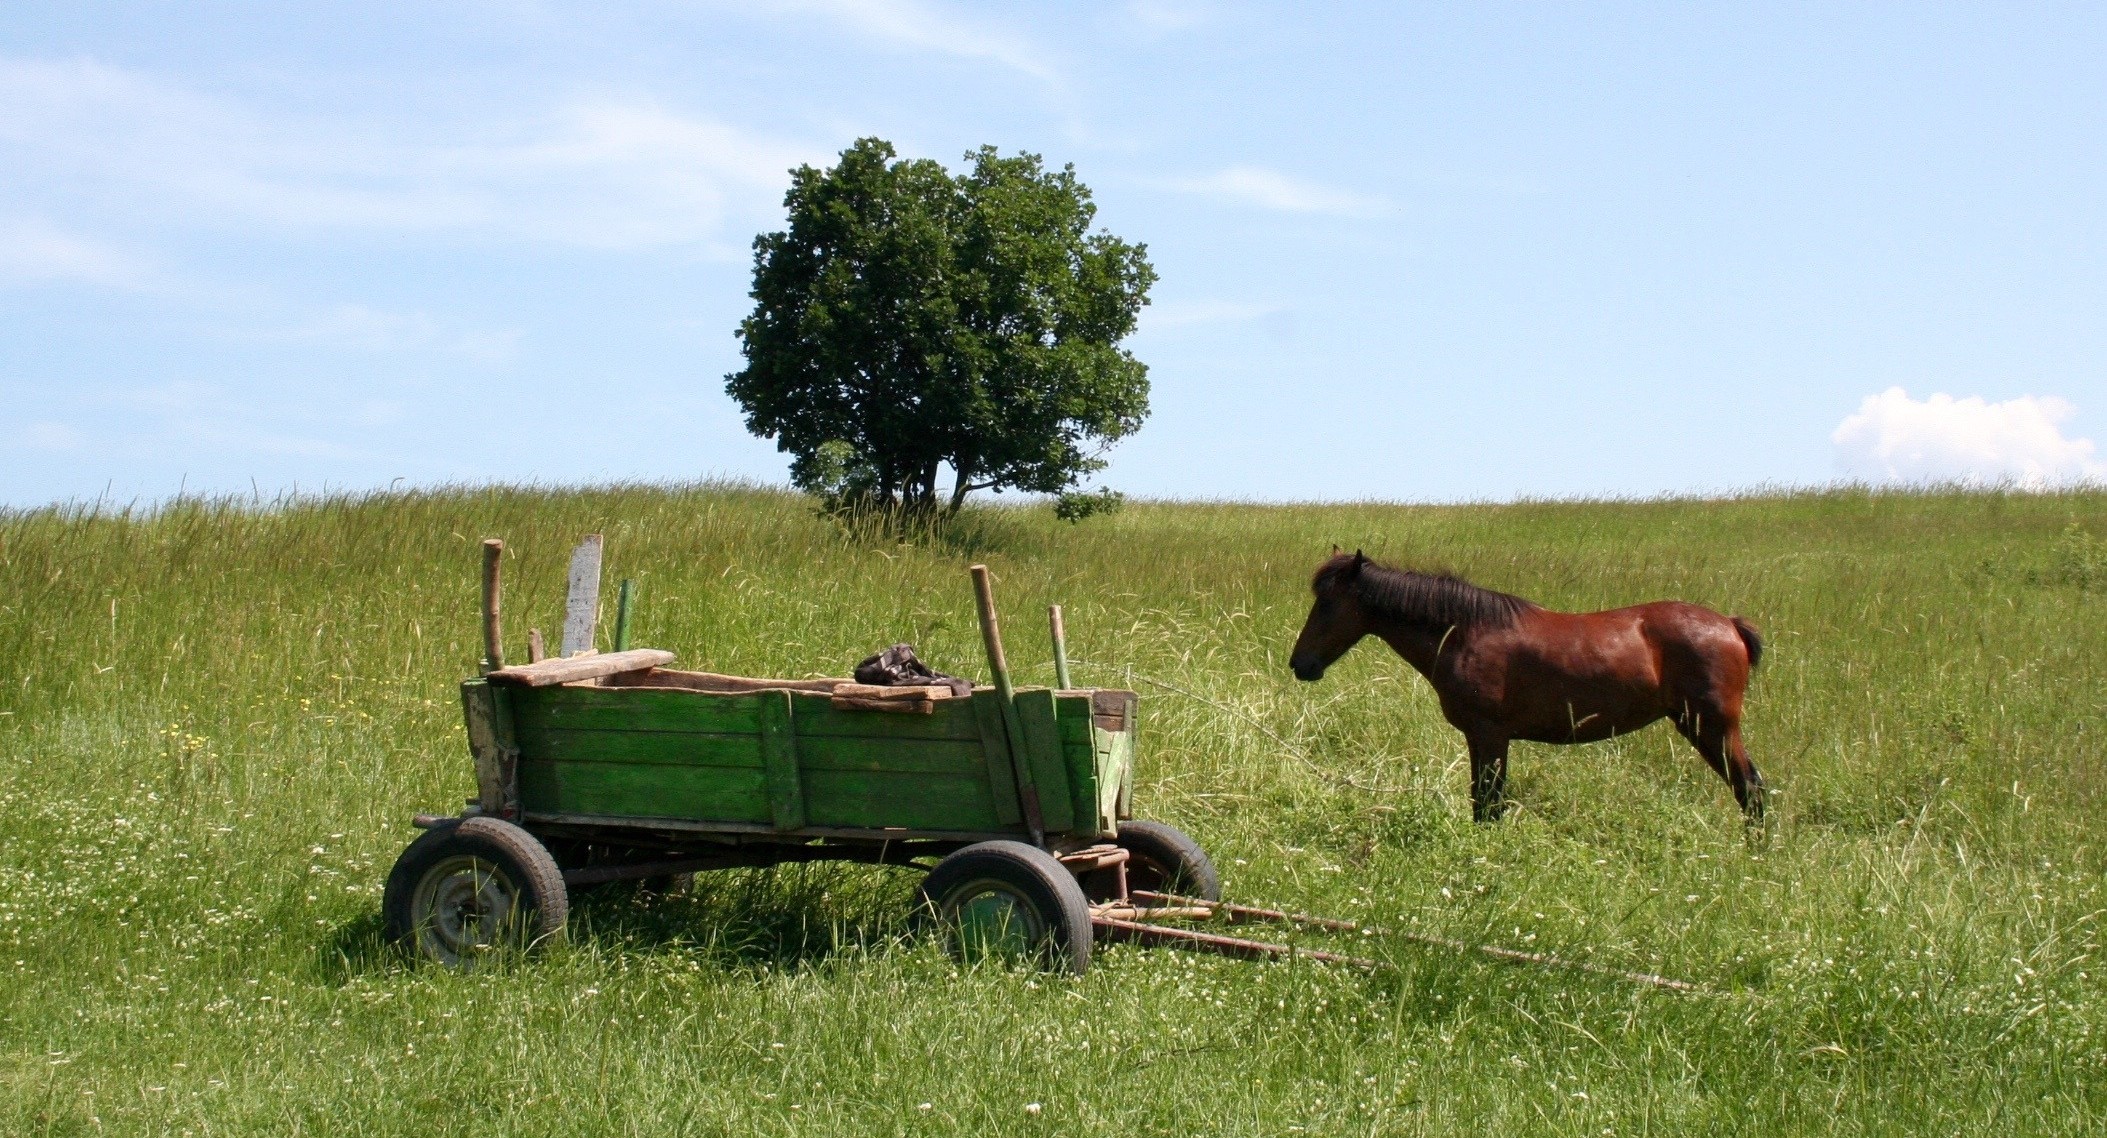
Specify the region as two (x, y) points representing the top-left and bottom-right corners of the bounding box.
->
(381, 818), (571, 967)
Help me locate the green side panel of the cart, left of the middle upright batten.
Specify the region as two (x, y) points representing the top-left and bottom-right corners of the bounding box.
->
(510, 687), (780, 824)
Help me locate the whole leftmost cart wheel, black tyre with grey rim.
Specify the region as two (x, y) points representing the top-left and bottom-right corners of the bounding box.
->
(381, 818), (571, 967)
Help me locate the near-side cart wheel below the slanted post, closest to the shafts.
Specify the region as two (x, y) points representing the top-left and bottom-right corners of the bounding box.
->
(919, 841), (1091, 976)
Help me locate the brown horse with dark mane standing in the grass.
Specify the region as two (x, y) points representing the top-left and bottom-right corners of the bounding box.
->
(1287, 550), (1764, 826)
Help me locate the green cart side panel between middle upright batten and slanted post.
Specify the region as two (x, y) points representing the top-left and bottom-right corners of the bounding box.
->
(792, 695), (1013, 832)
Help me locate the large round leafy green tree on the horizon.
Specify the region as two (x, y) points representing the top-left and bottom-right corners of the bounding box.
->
(725, 139), (1157, 512)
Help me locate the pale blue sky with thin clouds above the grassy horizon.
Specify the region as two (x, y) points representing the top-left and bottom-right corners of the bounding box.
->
(0, 0), (2107, 506)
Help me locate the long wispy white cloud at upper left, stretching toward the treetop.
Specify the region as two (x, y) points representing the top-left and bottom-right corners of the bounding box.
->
(0, 59), (826, 247)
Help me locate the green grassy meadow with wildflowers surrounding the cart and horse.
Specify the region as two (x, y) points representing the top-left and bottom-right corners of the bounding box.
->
(0, 487), (2107, 1136)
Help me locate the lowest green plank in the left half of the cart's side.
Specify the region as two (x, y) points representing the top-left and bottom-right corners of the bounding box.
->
(520, 759), (771, 822)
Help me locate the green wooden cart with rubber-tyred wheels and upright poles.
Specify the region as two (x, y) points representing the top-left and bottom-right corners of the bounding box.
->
(383, 546), (1220, 972)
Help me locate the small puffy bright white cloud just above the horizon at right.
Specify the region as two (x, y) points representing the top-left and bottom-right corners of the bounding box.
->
(1829, 388), (2107, 489)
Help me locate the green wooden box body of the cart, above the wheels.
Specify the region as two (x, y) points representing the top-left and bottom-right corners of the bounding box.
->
(461, 649), (1136, 839)
